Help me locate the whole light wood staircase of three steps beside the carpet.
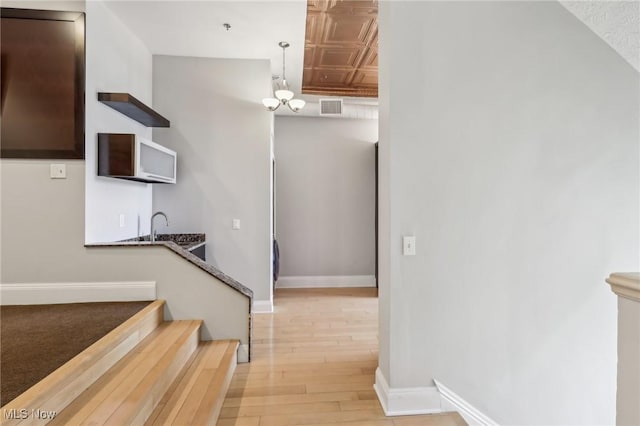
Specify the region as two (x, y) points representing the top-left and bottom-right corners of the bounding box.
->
(2, 301), (239, 426)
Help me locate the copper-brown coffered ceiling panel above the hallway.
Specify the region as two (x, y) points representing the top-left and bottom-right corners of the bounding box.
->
(302, 0), (378, 98)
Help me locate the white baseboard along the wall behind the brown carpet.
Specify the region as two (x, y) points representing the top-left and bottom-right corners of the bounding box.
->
(0, 281), (156, 305)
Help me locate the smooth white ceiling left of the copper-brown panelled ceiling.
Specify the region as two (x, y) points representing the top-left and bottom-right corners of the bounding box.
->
(105, 0), (307, 93)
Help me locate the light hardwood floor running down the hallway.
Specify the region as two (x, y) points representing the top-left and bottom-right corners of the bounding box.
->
(217, 288), (466, 426)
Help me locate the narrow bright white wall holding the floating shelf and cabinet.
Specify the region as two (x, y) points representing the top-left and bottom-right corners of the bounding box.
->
(85, 1), (154, 242)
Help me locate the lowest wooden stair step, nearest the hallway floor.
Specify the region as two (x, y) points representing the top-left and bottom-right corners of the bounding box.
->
(145, 340), (240, 426)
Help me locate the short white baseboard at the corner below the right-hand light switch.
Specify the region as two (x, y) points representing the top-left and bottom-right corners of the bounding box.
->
(373, 368), (442, 416)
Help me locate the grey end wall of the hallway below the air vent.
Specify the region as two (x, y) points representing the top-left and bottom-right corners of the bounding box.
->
(274, 116), (378, 278)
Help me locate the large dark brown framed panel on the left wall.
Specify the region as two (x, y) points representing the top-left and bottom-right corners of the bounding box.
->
(0, 7), (85, 159)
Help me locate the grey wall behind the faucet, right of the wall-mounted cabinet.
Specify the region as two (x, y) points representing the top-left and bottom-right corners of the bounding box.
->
(153, 56), (272, 303)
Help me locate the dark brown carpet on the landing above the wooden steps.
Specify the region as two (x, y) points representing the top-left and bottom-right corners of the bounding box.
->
(0, 302), (150, 406)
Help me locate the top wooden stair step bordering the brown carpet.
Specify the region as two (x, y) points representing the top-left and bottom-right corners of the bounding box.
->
(1, 300), (165, 426)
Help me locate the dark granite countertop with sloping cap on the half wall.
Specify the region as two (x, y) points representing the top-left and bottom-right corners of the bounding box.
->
(85, 234), (253, 299)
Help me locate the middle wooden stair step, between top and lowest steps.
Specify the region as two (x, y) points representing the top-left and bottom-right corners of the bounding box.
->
(50, 321), (202, 425)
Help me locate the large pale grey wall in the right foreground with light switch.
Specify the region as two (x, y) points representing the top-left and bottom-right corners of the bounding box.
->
(380, 2), (640, 425)
